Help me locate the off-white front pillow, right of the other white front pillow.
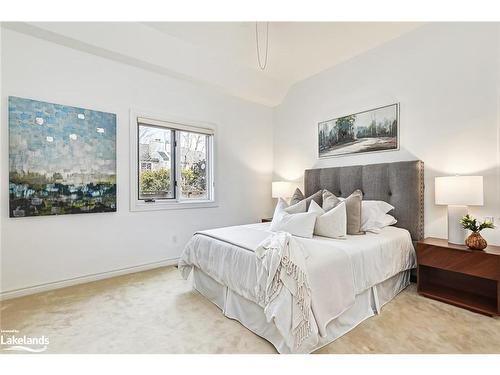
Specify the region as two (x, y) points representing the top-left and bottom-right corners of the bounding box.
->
(308, 201), (347, 238)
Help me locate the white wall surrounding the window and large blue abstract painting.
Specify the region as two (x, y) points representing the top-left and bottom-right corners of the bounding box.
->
(1, 29), (273, 292)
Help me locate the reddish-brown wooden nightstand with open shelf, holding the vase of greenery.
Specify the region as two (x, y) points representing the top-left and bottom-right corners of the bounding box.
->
(417, 238), (500, 316)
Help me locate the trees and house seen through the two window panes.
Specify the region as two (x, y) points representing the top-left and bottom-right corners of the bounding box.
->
(138, 124), (209, 199)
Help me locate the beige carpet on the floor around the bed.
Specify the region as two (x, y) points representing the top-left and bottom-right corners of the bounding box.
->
(0, 267), (500, 353)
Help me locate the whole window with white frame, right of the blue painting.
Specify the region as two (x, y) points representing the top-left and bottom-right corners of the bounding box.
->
(131, 116), (214, 210)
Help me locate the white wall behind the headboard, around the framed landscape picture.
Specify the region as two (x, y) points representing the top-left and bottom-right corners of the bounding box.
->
(274, 23), (500, 247)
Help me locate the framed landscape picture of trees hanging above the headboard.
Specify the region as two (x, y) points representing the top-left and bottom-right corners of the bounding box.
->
(318, 103), (399, 158)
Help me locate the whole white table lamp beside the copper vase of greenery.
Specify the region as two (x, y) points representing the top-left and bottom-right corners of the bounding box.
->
(435, 176), (483, 245)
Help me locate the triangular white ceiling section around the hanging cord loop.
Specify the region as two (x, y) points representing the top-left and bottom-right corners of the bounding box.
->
(145, 22), (421, 85)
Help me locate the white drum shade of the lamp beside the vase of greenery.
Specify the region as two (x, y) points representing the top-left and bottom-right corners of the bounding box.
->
(435, 176), (483, 206)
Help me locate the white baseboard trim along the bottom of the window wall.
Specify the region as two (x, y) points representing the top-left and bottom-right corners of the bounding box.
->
(0, 258), (179, 301)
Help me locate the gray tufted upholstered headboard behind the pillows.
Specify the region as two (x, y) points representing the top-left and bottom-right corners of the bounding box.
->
(304, 160), (424, 241)
